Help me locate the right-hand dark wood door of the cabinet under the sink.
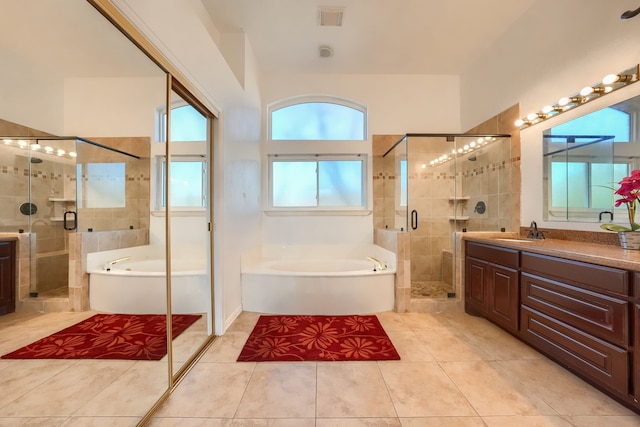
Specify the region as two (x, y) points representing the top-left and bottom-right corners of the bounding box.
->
(487, 264), (520, 333)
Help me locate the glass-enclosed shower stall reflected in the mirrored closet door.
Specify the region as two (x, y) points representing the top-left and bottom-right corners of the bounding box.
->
(0, 137), (144, 300)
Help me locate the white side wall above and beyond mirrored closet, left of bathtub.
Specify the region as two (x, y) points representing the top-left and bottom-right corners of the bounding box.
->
(113, 0), (261, 333)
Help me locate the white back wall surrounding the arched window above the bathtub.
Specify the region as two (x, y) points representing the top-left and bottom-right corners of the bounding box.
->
(261, 74), (460, 244)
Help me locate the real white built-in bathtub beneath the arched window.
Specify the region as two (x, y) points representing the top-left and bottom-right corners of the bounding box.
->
(242, 245), (396, 315)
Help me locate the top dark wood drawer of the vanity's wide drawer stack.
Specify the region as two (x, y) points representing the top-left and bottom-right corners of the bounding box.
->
(521, 252), (629, 296)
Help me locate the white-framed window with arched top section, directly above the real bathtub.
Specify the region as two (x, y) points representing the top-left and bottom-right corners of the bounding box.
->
(267, 96), (367, 211)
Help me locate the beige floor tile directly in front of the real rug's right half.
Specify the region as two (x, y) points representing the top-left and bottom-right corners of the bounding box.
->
(317, 362), (396, 418)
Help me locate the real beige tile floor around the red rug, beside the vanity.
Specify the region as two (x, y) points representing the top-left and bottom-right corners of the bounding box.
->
(150, 312), (640, 427)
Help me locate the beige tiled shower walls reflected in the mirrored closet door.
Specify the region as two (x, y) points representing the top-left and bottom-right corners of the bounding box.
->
(0, 119), (151, 311)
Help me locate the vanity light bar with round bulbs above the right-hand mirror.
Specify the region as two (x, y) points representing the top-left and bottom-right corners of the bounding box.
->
(515, 65), (640, 129)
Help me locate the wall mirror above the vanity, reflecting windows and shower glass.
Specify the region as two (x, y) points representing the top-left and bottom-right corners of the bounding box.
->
(543, 96), (640, 223)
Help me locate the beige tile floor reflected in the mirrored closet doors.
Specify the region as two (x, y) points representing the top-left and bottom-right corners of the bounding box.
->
(0, 312), (206, 427)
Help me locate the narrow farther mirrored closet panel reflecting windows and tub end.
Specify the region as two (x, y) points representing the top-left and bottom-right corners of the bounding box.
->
(165, 88), (213, 378)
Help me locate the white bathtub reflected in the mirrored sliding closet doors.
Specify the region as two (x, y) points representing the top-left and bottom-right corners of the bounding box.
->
(89, 259), (211, 314)
